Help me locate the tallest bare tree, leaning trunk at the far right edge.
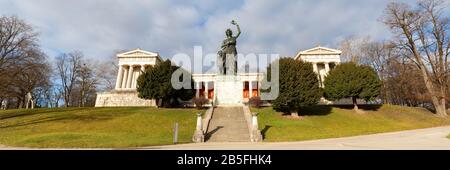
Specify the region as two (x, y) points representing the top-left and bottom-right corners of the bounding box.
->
(383, 0), (450, 117)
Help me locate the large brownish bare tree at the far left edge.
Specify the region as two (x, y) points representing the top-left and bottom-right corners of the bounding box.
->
(0, 16), (51, 108)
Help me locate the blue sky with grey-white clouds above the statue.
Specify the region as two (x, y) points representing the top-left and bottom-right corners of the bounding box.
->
(0, 0), (414, 59)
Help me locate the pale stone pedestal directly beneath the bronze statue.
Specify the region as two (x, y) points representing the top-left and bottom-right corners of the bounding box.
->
(214, 75), (244, 105)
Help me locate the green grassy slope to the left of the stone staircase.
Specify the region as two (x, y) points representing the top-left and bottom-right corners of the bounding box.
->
(0, 107), (198, 148)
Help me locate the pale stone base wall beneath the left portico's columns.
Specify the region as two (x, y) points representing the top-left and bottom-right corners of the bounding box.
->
(95, 91), (156, 107)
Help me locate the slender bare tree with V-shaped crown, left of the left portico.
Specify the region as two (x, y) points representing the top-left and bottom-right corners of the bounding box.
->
(56, 51), (83, 107)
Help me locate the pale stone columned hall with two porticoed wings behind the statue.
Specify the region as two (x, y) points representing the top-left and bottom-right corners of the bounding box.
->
(95, 46), (341, 107)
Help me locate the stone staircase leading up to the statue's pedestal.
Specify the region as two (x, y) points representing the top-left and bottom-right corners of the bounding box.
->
(205, 106), (250, 142)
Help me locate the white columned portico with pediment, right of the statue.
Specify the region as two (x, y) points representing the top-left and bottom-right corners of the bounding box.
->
(295, 46), (342, 87)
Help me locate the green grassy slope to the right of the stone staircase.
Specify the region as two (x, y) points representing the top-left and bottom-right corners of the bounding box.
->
(252, 105), (450, 142)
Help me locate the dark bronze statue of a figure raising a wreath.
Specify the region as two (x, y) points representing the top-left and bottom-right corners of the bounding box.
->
(217, 20), (241, 75)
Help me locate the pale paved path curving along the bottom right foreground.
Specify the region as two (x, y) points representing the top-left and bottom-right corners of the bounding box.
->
(142, 126), (450, 150)
